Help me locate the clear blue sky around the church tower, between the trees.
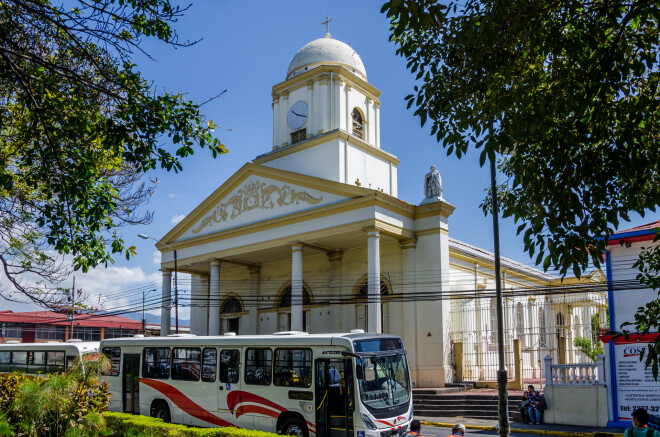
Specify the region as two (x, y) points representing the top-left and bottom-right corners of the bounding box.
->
(5, 0), (654, 311)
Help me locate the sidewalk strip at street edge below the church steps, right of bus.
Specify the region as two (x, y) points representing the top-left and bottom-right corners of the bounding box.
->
(415, 416), (625, 437)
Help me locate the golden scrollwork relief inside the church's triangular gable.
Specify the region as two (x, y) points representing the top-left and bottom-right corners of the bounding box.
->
(192, 181), (323, 234)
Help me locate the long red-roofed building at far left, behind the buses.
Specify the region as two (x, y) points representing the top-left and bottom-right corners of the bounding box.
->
(0, 311), (142, 343)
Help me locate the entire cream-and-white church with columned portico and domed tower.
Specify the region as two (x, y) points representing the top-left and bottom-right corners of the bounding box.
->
(157, 34), (606, 387)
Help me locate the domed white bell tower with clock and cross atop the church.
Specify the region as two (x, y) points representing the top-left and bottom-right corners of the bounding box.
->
(254, 33), (399, 196)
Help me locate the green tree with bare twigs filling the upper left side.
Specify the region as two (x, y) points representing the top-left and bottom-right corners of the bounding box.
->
(0, 0), (226, 305)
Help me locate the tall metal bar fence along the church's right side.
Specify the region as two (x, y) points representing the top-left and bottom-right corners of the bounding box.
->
(451, 292), (608, 383)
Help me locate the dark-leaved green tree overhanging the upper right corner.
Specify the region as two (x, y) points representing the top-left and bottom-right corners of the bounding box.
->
(382, 0), (660, 374)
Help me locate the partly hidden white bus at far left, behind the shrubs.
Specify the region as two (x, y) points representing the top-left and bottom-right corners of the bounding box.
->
(0, 340), (99, 375)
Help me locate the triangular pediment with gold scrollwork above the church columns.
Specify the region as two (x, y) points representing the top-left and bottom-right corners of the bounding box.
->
(162, 163), (373, 243)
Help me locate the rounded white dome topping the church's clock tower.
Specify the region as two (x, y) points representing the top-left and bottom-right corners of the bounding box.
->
(286, 34), (367, 80)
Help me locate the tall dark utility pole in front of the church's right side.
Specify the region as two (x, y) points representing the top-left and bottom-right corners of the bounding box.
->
(490, 157), (509, 437)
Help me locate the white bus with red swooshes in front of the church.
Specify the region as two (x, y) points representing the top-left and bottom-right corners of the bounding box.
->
(101, 331), (412, 437)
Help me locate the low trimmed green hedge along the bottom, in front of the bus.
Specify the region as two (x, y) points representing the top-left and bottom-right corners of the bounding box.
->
(103, 411), (278, 437)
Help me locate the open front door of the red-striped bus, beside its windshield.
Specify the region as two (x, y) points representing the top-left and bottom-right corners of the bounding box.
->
(315, 359), (355, 437)
